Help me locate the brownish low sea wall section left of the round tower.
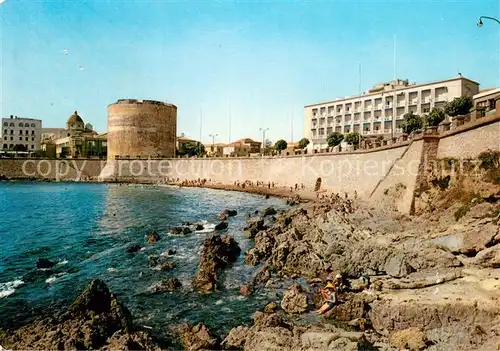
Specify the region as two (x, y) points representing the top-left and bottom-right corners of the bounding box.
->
(0, 159), (106, 181)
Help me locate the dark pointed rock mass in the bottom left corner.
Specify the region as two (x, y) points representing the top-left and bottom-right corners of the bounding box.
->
(2, 280), (139, 350)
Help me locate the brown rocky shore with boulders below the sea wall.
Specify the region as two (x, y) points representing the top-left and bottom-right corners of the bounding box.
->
(0, 169), (500, 351)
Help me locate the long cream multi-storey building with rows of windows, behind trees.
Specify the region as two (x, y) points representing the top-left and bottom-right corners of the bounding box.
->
(304, 75), (479, 149)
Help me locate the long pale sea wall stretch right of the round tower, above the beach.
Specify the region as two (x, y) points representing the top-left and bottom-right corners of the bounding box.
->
(101, 144), (408, 196)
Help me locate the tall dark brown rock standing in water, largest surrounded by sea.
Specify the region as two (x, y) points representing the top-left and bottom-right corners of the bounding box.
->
(193, 235), (241, 292)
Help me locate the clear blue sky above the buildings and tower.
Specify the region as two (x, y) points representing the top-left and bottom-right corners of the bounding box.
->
(0, 0), (500, 142)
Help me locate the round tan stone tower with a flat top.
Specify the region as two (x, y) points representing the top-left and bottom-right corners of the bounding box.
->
(108, 99), (177, 160)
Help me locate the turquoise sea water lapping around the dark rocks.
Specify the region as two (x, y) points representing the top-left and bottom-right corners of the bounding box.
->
(0, 182), (285, 335)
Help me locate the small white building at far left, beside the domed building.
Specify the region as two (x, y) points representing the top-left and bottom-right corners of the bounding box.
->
(0, 115), (42, 152)
